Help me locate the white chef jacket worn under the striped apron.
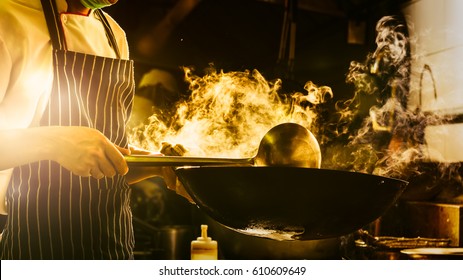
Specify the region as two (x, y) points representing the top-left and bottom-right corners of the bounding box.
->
(0, 0), (129, 213)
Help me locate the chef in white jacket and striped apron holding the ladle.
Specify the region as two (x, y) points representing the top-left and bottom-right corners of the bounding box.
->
(0, 0), (179, 259)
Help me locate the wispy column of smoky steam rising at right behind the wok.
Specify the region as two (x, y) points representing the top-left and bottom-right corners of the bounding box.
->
(330, 16), (461, 199)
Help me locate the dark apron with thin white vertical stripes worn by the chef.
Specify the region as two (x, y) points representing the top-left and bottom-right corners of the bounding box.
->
(1, 0), (134, 259)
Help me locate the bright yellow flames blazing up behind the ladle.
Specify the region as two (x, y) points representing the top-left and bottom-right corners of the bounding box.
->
(131, 68), (332, 157)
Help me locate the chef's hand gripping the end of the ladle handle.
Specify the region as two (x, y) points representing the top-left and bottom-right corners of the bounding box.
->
(50, 126), (130, 179)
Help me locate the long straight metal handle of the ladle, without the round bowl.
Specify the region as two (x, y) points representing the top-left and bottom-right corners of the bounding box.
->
(125, 155), (254, 166)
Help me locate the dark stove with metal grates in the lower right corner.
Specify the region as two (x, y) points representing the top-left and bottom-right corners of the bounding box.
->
(353, 201), (463, 260)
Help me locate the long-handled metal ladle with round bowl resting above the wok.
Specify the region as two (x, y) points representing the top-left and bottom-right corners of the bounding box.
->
(125, 123), (321, 168)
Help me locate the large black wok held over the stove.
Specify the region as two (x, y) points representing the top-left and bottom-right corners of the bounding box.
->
(176, 166), (407, 240)
